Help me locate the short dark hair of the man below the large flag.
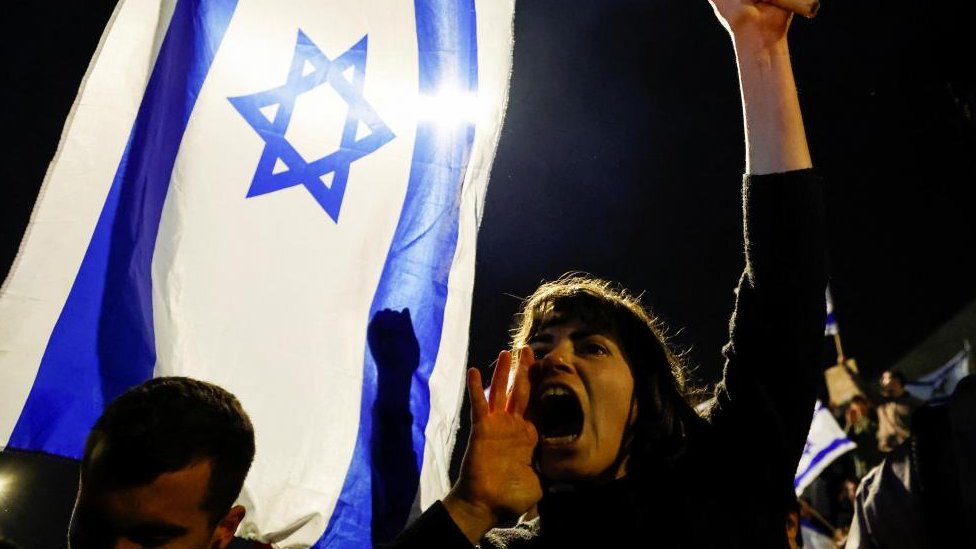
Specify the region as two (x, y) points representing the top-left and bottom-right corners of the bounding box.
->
(82, 376), (254, 524)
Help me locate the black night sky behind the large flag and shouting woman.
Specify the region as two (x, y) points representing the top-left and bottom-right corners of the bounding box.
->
(0, 0), (976, 547)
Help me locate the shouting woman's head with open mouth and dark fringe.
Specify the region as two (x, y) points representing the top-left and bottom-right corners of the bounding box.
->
(513, 275), (697, 482)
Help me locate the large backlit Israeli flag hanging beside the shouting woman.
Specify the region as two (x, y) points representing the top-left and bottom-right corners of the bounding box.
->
(0, 0), (514, 547)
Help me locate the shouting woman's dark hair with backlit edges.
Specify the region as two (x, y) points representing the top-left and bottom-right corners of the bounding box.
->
(512, 272), (700, 467)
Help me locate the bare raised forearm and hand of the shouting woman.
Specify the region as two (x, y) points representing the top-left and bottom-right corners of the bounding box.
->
(710, 0), (812, 175)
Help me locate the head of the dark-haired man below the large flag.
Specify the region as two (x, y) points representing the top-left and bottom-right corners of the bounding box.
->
(69, 377), (254, 549)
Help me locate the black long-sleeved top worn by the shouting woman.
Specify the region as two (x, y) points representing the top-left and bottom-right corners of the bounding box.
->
(392, 170), (827, 549)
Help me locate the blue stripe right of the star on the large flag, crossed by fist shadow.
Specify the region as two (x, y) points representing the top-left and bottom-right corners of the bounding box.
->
(315, 0), (478, 548)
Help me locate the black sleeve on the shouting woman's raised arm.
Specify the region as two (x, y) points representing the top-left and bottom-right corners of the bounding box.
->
(711, 169), (827, 485)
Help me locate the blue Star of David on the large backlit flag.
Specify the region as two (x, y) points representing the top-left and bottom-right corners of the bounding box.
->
(228, 30), (395, 223)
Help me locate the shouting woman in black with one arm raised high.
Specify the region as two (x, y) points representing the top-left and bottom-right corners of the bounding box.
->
(386, 0), (826, 548)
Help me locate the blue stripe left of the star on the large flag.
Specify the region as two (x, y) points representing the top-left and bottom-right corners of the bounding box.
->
(9, 0), (237, 458)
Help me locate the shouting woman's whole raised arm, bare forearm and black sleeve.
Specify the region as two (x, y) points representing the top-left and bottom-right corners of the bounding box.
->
(710, 0), (827, 512)
